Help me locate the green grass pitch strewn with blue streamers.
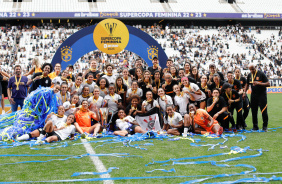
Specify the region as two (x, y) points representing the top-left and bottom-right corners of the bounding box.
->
(0, 94), (282, 184)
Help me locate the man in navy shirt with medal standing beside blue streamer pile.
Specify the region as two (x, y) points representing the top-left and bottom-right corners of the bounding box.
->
(8, 65), (28, 112)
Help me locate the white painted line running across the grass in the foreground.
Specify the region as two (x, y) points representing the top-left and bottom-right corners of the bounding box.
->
(81, 139), (114, 184)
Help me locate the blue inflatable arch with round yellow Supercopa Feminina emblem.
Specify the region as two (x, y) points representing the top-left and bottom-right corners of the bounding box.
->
(52, 19), (168, 69)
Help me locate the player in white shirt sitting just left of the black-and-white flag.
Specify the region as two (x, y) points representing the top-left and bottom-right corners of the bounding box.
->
(114, 109), (150, 136)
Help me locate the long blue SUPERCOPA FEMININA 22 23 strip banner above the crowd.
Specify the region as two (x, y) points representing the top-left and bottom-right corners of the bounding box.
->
(0, 12), (282, 20)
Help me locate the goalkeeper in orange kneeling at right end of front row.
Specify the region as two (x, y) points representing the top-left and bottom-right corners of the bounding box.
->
(184, 104), (223, 135)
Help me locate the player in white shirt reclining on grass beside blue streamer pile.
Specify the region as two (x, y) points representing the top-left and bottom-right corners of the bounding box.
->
(17, 114), (75, 143)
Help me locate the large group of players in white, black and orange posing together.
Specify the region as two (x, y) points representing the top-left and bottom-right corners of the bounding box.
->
(18, 58), (267, 142)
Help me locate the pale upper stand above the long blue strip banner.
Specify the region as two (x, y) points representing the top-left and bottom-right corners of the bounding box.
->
(0, 0), (282, 13)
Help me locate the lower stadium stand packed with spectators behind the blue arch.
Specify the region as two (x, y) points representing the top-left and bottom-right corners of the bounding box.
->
(0, 24), (282, 77)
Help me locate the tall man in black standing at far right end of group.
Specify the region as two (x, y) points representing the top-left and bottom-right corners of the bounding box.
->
(246, 63), (270, 131)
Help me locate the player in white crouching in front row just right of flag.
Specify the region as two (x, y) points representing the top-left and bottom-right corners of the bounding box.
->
(163, 105), (183, 135)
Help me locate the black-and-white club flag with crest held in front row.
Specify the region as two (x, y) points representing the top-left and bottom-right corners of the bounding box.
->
(135, 107), (161, 131)
